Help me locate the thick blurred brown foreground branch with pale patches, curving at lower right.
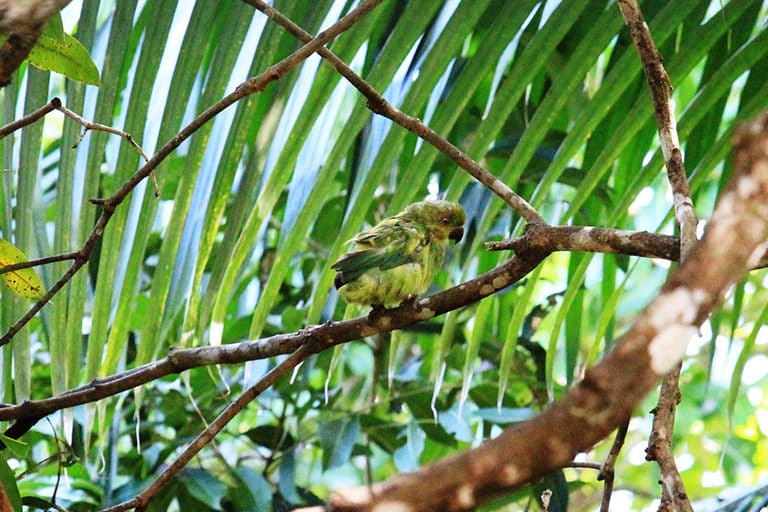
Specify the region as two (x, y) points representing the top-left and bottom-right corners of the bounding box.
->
(322, 115), (768, 512)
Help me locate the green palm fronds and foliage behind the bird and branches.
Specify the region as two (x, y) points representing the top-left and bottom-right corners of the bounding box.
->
(0, 0), (768, 510)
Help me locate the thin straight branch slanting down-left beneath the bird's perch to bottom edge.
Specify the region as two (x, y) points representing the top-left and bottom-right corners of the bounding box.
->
(102, 345), (313, 512)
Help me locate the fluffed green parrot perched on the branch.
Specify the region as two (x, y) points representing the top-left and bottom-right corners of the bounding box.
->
(332, 201), (464, 309)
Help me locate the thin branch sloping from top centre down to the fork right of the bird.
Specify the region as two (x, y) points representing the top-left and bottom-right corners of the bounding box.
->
(243, 0), (545, 224)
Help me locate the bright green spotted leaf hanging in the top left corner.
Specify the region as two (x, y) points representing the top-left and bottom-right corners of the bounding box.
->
(28, 33), (100, 85)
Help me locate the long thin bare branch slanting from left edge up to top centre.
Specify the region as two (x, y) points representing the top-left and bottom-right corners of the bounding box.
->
(0, 0), (383, 346)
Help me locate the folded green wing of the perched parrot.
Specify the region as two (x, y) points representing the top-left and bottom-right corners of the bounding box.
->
(332, 219), (425, 286)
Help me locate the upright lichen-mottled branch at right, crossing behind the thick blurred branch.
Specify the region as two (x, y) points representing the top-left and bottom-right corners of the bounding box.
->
(618, 0), (698, 512)
